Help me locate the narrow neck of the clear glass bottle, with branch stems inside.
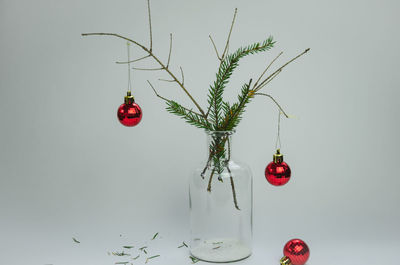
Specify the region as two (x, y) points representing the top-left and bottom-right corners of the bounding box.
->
(206, 131), (234, 171)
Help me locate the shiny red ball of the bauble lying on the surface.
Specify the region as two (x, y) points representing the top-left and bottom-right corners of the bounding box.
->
(283, 239), (310, 265)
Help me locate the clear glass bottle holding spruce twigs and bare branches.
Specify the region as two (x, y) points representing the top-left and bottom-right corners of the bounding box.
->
(189, 131), (253, 262)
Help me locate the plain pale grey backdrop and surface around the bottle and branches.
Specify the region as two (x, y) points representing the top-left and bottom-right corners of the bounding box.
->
(0, 0), (400, 265)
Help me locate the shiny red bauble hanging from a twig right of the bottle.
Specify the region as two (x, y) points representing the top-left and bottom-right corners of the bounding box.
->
(265, 149), (291, 186)
